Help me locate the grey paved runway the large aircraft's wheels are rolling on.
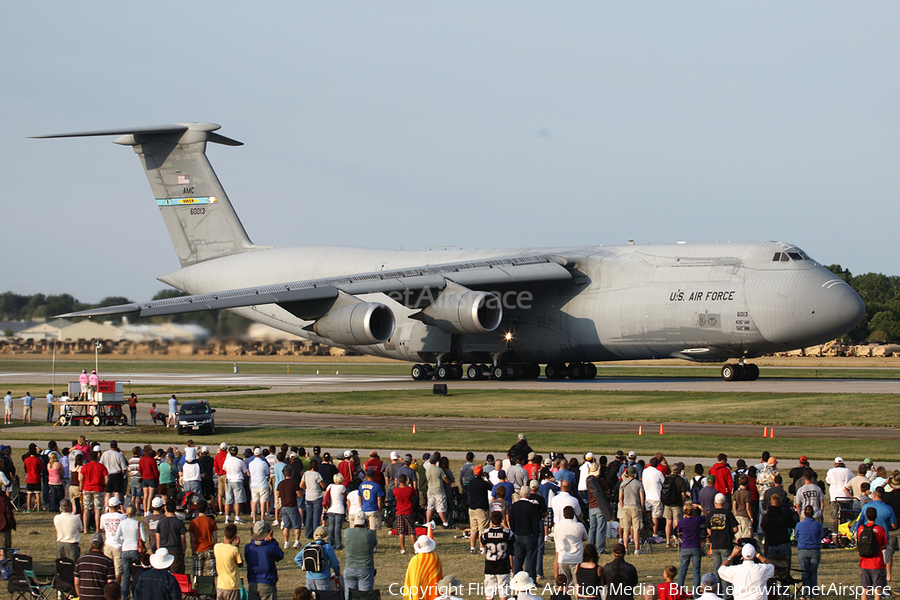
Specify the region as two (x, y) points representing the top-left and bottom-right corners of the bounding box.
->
(0, 372), (900, 395)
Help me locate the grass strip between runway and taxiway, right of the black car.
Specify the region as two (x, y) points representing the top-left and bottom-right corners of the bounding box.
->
(185, 389), (900, 428)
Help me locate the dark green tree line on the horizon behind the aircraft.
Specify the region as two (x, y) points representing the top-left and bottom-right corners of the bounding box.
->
(0, 265), (900, 343)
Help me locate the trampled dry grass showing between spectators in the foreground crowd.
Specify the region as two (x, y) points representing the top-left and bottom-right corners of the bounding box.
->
(5, 452), (859, 598)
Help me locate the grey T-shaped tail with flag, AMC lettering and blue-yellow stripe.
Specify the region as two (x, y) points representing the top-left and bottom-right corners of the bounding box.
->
(34, 123), (259, 267)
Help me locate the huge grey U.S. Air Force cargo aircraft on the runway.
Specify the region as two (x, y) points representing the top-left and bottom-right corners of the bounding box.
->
(36, 123), (865, 381)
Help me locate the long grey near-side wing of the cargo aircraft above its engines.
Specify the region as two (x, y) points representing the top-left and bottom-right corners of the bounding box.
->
(58, 254), (572, 319)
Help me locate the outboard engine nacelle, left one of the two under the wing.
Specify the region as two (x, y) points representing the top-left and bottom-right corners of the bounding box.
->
(313, 302), (394, 346)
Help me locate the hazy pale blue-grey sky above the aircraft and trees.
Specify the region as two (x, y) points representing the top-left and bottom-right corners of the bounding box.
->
(0, 0), (900, 302)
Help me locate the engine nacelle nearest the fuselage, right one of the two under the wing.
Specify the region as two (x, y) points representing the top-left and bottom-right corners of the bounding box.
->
(421, 284), (503, 333)
